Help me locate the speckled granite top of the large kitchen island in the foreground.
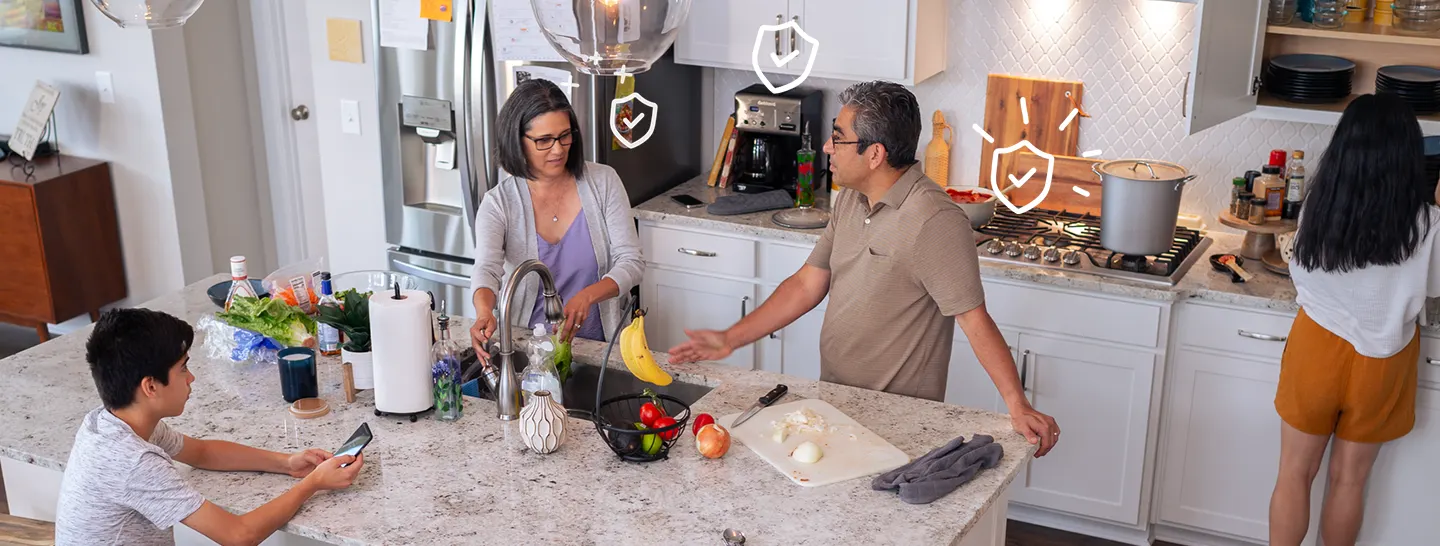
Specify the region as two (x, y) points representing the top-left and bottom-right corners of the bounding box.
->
(0, 275), (1034, 545)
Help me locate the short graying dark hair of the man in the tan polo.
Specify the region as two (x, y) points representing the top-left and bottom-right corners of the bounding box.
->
(840, 81), (920, 169)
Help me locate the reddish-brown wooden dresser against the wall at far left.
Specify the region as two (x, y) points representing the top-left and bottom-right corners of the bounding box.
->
(0, 156), (127, 341)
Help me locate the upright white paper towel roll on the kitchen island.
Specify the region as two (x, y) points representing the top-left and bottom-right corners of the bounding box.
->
(370, 290), (435, 413)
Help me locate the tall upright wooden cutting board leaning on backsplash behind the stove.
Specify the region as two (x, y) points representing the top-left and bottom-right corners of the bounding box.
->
(976, 73), (1084, 207)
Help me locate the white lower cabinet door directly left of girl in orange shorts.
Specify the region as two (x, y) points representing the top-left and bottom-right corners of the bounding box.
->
(1159, 349), (1322, 543)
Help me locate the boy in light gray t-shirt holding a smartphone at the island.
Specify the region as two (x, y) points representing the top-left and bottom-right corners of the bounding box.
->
(55, 308), (364, 546)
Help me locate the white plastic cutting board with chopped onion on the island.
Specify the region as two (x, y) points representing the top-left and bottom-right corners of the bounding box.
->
(719, 399), (910, 487)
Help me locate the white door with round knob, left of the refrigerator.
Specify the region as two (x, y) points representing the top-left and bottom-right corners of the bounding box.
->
(251, 0), (331, 265)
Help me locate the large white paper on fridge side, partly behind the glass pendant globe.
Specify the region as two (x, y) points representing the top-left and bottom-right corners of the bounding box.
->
(490, 0), (580, 62)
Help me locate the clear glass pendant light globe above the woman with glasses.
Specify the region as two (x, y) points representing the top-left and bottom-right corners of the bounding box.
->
(530, 0), (691, 76)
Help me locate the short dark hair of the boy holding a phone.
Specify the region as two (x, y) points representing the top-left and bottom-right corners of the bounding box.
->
(85, 308), (194, 409)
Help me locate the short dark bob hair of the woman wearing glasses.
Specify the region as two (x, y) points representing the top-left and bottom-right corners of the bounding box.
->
(495, 79), (585, 179)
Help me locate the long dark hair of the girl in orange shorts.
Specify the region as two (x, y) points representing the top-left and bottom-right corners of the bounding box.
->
(1295, 94), (1434, 272)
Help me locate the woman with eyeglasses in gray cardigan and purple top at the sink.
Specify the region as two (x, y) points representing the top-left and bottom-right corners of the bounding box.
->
(469, 79), (644, 348)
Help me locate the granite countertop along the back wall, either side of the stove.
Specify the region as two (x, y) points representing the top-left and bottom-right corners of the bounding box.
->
(635, 177), (1299, 313)
